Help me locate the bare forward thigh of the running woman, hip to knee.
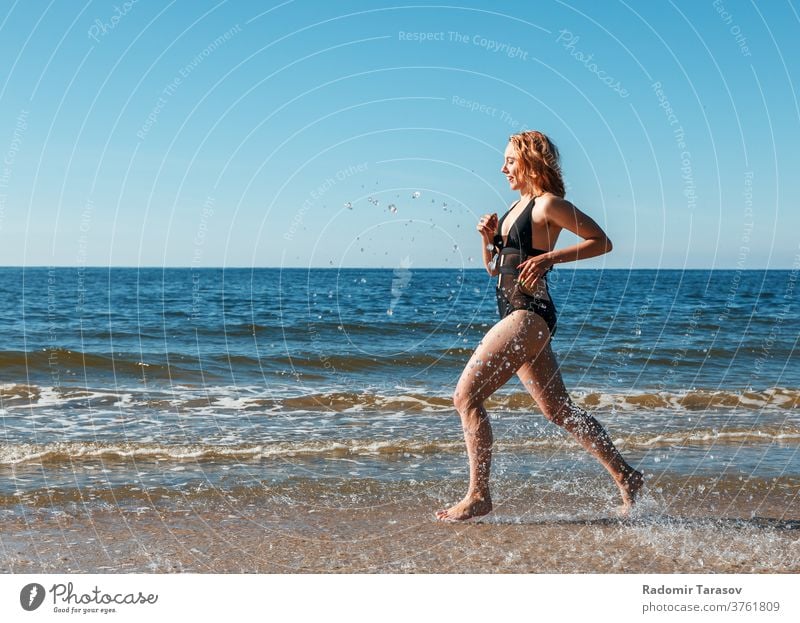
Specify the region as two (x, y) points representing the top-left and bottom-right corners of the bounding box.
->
(455, 311), (550, 404)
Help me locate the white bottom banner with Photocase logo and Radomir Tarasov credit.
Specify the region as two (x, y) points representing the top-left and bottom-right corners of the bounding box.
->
(0, 574), (800, 623)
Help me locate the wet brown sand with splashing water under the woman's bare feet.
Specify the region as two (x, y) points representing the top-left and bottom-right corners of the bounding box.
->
(0, 478), (800, 573)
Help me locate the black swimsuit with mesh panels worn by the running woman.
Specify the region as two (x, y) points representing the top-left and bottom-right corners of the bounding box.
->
(494, 197), (556, 336)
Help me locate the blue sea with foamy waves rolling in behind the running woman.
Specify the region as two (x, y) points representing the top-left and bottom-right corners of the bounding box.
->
(0, 267), (800, 508)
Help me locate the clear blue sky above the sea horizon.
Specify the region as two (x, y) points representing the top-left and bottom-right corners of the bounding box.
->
(0, 0), (800, 269)
